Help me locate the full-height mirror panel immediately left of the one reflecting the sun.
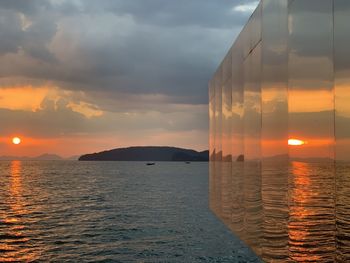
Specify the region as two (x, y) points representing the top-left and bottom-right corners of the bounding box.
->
(261, 0), (289, 262)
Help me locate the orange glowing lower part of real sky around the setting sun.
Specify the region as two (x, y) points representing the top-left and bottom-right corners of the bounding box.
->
(0, 85), (207, 157)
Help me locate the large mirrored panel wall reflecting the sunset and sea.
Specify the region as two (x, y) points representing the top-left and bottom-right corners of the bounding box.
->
(209, 0), (350, 262)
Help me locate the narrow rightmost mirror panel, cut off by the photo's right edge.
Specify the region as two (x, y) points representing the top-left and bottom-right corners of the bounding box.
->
(334, 0), (350, 262)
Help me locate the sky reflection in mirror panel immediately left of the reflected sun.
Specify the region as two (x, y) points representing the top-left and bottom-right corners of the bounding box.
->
(261, 0), (288, 159)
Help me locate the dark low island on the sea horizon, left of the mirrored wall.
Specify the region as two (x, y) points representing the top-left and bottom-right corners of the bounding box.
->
(79, 146), (209, 162)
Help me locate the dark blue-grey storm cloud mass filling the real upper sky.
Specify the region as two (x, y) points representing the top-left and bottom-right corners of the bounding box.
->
(0, 0), (254, 104)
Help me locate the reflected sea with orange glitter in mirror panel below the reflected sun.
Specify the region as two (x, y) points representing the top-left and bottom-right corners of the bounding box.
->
(288, 162), (336, 262)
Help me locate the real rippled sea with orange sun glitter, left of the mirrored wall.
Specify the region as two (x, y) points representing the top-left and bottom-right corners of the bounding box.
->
(0, 161), (259, 262)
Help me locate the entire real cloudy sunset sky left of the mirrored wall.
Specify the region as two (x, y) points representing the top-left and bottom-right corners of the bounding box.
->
(0, 0), (258, 157)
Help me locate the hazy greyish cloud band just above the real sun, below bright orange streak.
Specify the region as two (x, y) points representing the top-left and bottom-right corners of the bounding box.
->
(0, 98), (208, 137)
